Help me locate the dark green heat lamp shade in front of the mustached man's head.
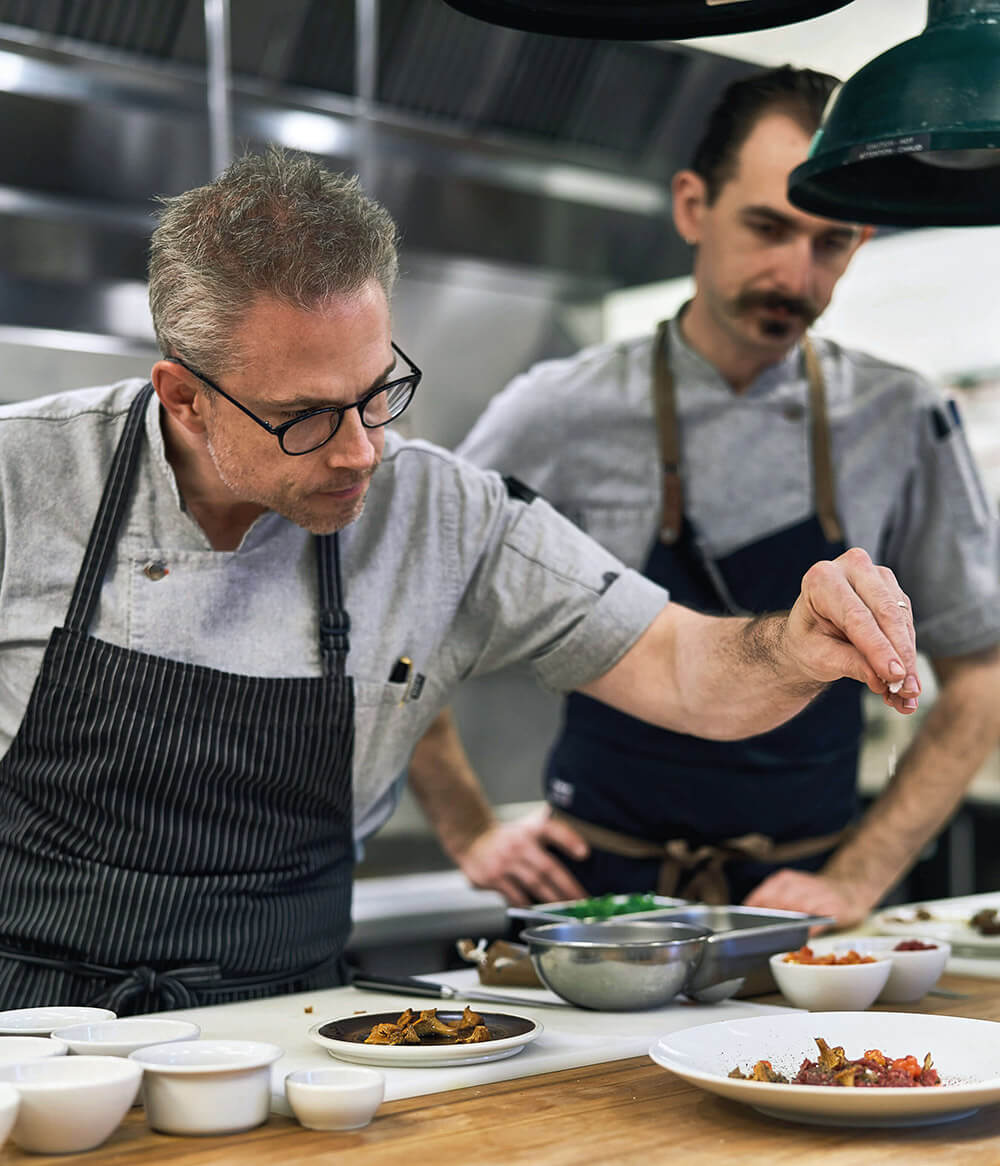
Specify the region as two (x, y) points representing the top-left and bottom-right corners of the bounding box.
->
(788, 0), (1000, 226)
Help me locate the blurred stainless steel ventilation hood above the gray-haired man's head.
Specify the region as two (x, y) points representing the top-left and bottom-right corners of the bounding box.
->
(0, 0), (746, 340)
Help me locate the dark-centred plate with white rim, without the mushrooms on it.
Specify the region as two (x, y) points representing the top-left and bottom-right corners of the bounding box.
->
(309, 1009), (542, 1068)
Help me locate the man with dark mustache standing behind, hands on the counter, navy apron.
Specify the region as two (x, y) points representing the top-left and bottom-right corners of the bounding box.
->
(410, 68), (1000, 923)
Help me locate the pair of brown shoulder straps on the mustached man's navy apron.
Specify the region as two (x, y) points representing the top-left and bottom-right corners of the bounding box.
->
(653, 319), (845, 545)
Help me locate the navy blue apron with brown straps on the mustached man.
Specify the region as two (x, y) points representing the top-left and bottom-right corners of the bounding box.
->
(547, 324), (862, 902)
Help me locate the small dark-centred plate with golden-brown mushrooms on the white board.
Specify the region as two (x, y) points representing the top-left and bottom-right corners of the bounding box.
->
(309, 1006), (542, 1068)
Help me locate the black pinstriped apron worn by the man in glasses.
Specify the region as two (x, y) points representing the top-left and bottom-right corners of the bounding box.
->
(0, 385), (354, 1013)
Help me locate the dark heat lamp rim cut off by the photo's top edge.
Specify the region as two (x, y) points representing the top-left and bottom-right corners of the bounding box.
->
(435, 0), (848, 41)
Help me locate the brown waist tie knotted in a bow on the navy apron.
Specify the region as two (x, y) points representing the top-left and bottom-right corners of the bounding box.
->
(551, 807), (848, 904)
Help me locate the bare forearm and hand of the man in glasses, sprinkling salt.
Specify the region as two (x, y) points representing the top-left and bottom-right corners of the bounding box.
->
(582, 548), (920, 740)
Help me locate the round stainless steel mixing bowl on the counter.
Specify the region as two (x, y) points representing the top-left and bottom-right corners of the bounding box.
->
(521, 920), (712, 1012)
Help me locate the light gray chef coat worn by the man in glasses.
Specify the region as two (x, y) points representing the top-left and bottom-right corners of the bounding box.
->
(0, 380), (667, 838)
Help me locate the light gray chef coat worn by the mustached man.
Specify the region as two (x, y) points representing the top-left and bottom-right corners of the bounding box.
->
(458, 321), (1000, 658)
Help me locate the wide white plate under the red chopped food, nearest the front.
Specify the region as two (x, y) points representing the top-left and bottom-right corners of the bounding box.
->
(649, 1012), (1000, 1126)
